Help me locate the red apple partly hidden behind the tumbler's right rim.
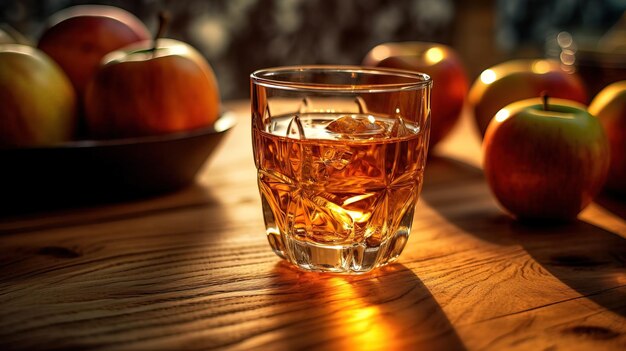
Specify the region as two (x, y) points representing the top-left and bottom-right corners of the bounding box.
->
(363, 42), (469, 150)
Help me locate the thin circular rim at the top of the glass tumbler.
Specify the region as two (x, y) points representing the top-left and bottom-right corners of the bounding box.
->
(250, 65), (433, 93)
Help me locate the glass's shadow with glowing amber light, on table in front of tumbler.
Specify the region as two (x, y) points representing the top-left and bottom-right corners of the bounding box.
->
(263, 262), (465, 350)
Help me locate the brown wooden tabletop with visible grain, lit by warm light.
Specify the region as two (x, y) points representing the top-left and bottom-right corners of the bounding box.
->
(0, 102), (626, 350)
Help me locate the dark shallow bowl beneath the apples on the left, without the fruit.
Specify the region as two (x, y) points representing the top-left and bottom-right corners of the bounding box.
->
(0, 113), (235, 213)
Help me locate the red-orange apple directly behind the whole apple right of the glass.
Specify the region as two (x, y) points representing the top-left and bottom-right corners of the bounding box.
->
(468, 59), (587, 136)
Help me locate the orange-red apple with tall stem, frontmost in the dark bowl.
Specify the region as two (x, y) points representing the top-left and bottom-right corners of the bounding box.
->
(85, 39), (220, 138)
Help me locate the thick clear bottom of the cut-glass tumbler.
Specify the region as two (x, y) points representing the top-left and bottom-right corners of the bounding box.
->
(267, 228), (410, 274)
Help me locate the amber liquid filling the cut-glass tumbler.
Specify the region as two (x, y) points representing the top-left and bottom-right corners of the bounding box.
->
(253, 114), (427, 272)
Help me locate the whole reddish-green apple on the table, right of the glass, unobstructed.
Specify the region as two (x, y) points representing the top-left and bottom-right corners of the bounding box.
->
(483, 98), (609, 220)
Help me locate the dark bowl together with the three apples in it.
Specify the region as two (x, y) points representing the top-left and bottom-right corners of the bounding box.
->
(0, 5), (235, 209)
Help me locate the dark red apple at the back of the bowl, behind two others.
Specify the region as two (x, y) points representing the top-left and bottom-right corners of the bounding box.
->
(38, 5), (151, 99)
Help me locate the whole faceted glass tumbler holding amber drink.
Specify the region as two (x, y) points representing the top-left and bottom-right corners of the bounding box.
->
(250, 66), (432, 273)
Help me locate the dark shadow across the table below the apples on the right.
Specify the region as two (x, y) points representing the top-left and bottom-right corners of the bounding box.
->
(421, 158), (626, 316)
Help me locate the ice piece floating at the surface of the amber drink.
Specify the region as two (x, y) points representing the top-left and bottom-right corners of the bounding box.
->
(326, 115), (387, 139)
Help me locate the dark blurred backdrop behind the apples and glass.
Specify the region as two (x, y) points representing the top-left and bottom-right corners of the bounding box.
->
(0, 0), (626, 99)
